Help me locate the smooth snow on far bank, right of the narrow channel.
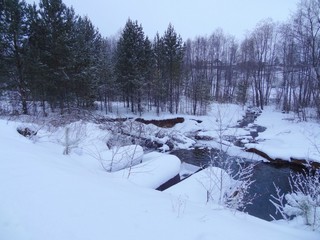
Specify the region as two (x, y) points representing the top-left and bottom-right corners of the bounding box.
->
(246, 107), (320, 162)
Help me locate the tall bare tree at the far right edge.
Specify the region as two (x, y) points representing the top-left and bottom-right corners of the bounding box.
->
(292, 0), (320, 117)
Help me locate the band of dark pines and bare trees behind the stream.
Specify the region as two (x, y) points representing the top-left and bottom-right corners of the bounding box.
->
(0, 0), (320, 118)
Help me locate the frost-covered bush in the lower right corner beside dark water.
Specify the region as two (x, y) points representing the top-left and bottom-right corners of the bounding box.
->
(270, 170), (320, 230)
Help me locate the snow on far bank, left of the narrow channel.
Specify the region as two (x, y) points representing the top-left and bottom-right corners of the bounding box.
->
(165, 104), (261, 161)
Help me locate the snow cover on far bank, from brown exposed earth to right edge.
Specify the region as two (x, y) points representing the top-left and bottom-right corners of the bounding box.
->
(116, 104), (320, 166)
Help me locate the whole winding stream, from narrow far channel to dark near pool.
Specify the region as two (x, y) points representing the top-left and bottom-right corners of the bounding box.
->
(171, 108), (302, 221)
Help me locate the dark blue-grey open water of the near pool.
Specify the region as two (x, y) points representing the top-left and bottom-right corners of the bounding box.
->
(171, 149), (301, 221)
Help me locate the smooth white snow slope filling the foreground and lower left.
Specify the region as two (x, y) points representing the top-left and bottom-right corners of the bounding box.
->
(0, 120), (320, 240)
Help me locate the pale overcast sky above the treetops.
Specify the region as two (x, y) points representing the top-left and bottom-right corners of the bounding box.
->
(27, 0), (299, 40)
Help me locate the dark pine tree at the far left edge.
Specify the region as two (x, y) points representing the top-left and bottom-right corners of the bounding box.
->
(0, 0), (29, 114)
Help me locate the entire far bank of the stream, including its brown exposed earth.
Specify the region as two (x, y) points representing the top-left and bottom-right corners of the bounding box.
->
(7, 104), (320, 167)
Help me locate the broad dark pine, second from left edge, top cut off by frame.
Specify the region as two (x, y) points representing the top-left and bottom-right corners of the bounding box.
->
(34, 0), (75, 114)
